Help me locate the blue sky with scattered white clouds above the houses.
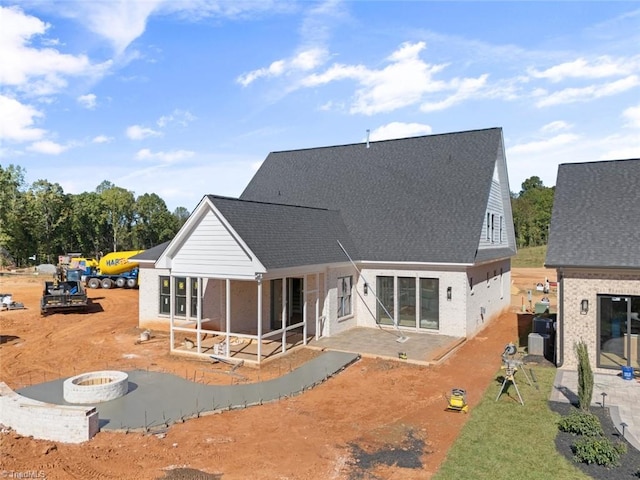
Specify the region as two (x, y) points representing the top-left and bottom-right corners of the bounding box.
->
(0, 0), (640, 211)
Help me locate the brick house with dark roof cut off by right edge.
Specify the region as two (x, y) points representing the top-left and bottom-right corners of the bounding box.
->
(545, 159), (640, 372)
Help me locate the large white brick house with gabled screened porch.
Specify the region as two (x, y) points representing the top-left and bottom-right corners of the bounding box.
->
(136, 128), (516, 362)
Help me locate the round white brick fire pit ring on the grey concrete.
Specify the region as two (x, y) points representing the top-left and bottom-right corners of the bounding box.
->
(62, 370), (129, 404)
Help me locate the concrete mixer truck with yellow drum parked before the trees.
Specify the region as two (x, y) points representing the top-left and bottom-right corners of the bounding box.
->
(68, 250), (144, 288)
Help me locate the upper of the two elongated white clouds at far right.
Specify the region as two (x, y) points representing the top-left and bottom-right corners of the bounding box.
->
(528, 56), (639, 83)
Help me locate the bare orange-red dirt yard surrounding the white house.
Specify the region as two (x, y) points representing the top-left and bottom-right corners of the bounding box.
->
(0, 268), (555, 480)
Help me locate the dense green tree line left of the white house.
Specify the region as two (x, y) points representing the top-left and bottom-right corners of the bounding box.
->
(0, 165), (189, 267)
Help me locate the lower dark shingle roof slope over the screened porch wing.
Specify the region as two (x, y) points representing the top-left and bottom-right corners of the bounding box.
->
(207, 195), (357, 270)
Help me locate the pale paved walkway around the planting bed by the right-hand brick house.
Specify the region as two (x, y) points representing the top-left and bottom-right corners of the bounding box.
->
(549, 370), (640, 450)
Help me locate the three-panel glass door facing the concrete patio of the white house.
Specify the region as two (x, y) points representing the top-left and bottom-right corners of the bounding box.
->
(376, 277), (440, 330)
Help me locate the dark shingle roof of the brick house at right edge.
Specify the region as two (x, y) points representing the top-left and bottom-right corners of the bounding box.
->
(545, 159), (640, 268)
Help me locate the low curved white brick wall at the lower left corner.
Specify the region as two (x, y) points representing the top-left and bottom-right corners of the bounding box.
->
(0, 382), (100, 443)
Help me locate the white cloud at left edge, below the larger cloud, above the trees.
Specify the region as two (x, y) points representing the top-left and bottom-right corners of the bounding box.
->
(0, 94), (46, 142)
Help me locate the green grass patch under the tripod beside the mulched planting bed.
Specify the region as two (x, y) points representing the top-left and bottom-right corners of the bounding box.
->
(433, 367), (589, 480)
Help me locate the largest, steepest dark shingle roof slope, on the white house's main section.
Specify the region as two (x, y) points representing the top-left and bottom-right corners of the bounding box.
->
(240, 128), (504, 263)
